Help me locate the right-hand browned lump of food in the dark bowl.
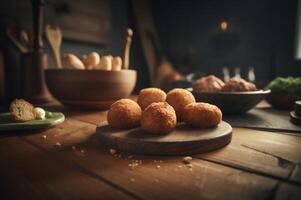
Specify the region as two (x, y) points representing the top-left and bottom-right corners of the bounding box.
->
(222, 77), (257, 92)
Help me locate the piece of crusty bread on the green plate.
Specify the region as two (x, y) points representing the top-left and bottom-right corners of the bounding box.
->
(9, 99), (37, 122)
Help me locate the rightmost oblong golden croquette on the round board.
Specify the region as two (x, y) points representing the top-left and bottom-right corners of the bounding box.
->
(183, 103), (222, 128)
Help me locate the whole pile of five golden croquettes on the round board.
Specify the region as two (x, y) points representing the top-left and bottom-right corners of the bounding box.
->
(107, 88), (222, 134)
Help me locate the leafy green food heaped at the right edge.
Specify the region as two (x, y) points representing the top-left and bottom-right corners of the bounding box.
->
(267, 77), (301, 95)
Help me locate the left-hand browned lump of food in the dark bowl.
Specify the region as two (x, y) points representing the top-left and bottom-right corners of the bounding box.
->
(193, 75), (225, 92)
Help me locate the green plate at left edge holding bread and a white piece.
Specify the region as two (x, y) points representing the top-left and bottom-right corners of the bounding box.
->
(0, 112), (65, 131)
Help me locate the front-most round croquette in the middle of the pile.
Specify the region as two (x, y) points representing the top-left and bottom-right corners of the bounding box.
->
(141, 102), (177, 134)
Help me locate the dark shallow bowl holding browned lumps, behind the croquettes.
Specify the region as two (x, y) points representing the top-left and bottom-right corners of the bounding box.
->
(190, 89), (271, 114)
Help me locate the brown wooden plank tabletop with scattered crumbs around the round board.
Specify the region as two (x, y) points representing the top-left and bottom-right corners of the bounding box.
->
(0, 102), (301, 199)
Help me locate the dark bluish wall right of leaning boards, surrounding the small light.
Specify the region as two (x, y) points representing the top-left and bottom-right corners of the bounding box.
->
(152, 0), (301, 82)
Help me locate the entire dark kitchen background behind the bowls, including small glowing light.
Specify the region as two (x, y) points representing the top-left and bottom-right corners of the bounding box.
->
(0, 0), (301, 102)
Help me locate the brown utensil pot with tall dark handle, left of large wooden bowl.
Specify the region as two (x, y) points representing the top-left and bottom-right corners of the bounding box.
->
(21, 0), (51, 104)
